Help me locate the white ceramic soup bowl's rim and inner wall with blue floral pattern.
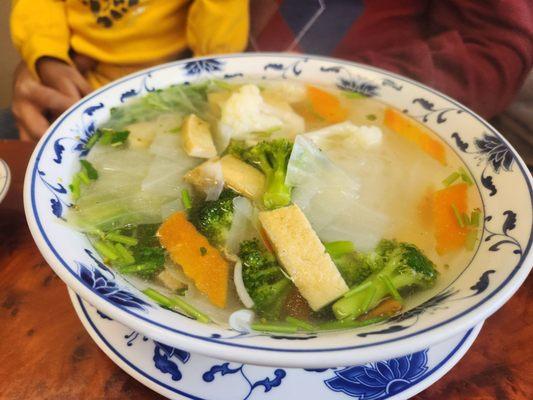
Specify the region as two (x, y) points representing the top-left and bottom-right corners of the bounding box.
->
(24, 54), (533, 368)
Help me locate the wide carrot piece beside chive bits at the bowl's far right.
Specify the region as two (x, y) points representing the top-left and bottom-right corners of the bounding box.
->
(433, 183), (468, 254)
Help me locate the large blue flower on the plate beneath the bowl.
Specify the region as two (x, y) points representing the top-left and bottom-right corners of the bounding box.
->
(325, 350), (428, 400)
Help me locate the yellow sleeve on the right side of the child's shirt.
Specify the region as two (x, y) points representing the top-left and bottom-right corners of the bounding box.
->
(187, 0), (249, 56)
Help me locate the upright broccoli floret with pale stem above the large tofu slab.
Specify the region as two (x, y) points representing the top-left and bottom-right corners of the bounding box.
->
(241, 139), (292, 210)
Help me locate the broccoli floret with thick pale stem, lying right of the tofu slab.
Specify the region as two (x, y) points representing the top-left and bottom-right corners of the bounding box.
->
(333, 240), (437, 319)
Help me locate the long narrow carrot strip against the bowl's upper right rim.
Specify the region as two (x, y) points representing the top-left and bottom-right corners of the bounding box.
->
(384, 107), (446, 165)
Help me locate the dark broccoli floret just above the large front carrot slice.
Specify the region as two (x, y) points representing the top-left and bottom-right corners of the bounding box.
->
(189, 189), (237, 247)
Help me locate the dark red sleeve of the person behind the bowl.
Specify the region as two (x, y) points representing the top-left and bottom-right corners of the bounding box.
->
(335, 0), (533, 118)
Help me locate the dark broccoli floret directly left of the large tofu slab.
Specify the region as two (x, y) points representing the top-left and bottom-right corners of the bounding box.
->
(239, 239), (292, 320)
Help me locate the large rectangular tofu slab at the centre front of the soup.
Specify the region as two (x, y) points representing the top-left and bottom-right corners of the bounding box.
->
(259, 205), (348, 311)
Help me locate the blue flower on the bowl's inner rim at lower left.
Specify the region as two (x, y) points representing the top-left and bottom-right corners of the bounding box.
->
(78, 263), (150, 310)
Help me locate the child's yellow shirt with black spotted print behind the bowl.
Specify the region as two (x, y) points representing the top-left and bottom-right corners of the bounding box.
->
(11, 0), (249, 87)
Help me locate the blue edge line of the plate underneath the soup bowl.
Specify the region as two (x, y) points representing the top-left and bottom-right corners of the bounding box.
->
(75, 294), (477, 400)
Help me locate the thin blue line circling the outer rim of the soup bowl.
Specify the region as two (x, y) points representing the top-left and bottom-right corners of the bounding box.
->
(28, 53), (533, 353)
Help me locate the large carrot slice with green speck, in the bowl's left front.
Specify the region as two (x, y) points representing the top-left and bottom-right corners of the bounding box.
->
(157, 212), (229, 308)
